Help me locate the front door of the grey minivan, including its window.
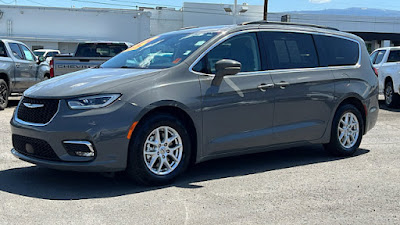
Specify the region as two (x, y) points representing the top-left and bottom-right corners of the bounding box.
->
(193, 33), (275, 155)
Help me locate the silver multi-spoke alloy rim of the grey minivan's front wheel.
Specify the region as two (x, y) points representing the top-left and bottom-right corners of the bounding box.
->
(143, 126), (183, 175)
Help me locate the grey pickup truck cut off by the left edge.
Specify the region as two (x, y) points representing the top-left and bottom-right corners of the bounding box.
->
(0, 39), (50, 110)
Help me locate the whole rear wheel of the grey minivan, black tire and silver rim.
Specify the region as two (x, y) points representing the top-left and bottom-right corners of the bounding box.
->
(324, 104), (364, 156)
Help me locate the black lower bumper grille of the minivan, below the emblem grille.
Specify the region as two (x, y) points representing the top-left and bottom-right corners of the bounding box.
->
(12, 134), (61, 161)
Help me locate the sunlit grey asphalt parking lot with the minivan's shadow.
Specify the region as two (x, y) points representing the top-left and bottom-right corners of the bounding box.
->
(0, 98), (400, 224)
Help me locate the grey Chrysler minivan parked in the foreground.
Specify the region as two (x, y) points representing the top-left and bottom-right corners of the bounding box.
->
(11, 22), (379, 185)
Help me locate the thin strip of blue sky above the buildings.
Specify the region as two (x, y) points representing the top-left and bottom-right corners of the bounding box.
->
(0, 0), (400, 12)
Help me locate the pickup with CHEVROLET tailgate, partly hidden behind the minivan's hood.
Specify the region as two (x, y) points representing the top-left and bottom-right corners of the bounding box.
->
(50, 42), (132, 77)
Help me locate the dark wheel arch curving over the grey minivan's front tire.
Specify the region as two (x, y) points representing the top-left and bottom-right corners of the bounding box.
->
(131, 101), (199, 164)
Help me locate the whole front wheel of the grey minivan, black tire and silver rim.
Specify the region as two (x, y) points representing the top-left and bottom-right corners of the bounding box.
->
(126, 114), (192, 185)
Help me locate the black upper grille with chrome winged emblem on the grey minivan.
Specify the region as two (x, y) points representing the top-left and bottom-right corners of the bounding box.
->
(17, 97), (59, 124)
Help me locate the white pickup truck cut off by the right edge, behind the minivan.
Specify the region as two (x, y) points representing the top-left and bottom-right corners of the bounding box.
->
(370, 47), (400, 107)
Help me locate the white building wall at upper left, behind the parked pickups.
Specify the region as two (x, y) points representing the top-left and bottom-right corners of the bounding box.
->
(0, 5), (150, 51)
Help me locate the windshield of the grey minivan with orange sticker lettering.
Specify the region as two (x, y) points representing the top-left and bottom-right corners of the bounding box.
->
(101, 31), (217, 69)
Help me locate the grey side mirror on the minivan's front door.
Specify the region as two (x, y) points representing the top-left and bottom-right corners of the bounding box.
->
(211, 59), (242, 86)
